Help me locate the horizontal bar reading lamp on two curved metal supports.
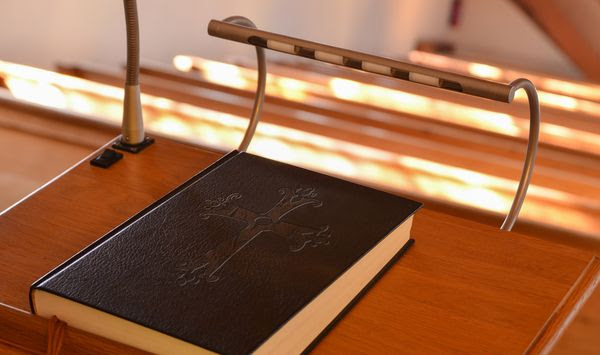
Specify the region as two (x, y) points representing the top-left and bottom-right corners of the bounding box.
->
(208, 16), (540, 231)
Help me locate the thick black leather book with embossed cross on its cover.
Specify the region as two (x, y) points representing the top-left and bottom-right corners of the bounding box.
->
(30, 152), (421, 354)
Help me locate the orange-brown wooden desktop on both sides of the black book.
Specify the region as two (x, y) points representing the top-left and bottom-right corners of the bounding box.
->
(0, 139), (600, 353)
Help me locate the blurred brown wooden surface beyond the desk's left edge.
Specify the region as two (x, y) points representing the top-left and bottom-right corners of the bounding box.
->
(0, 92), (119, 211)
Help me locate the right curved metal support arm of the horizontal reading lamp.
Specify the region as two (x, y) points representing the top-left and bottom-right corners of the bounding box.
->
(500, 79), (540, 231)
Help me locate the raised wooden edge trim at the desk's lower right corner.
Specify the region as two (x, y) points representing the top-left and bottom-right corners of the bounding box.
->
(524, 256), (600, 354)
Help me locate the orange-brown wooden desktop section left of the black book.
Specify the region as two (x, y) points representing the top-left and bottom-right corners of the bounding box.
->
(0, 139), (221, 309)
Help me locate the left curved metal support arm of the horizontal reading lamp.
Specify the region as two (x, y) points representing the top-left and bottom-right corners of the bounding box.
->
(223, 16), (267, 152)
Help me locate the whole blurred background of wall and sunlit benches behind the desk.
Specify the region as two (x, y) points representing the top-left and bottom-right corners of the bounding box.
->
(0, 0), (600, 245)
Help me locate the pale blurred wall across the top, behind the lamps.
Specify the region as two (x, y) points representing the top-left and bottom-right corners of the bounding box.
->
(0, 0), (450, 68)
